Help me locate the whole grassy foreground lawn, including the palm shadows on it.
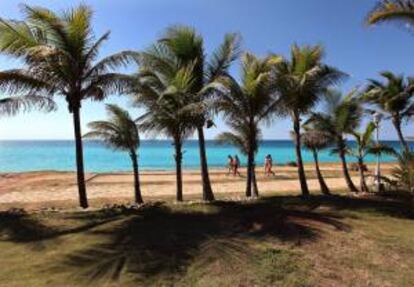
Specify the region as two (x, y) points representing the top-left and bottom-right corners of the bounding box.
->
(0, 196), (414, 287)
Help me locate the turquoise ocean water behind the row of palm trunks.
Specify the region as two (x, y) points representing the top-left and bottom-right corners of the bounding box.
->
(0, 140), (408, 172)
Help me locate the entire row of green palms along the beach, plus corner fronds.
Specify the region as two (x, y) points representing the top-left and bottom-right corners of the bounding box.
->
(0, 1), (414, 208)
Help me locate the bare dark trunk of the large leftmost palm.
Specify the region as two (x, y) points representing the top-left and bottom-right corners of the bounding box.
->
(72, 107), (88, 208)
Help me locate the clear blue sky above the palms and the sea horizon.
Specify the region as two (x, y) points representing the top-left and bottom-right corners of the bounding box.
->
(0, 0), (414, 139)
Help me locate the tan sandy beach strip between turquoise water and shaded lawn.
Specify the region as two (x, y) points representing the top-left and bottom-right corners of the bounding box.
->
(0, 164), (393, 208)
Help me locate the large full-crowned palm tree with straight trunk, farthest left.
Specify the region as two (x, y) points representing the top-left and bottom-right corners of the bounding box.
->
(0, 5), (133, 208)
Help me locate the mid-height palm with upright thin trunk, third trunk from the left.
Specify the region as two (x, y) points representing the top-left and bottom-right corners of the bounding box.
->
(134, 58), (194, 201)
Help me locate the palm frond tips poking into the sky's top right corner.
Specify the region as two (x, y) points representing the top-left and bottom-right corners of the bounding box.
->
(367, 0), (414, 25)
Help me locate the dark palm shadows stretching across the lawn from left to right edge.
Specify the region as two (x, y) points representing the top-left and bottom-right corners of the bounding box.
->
(0, 196), (414, 286)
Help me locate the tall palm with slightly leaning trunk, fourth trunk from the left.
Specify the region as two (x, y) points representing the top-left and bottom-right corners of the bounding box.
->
(145, 26), (239, 201)
